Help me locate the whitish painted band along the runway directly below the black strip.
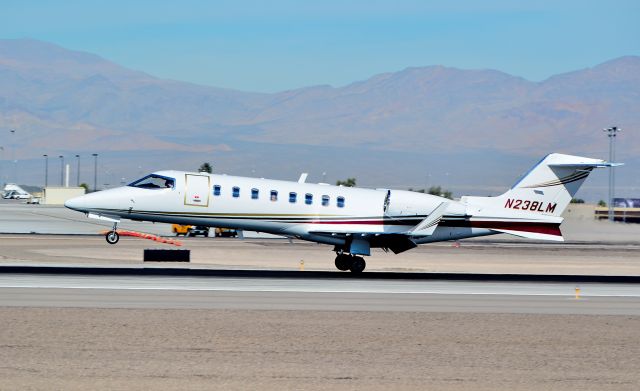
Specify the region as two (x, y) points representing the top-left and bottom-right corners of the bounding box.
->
(0, 274), (640, 297)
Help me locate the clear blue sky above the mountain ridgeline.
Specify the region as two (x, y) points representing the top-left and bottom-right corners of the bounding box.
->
(0, 0), (640, 92)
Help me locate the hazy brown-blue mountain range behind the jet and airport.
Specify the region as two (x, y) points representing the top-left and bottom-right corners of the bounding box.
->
(0, 39), (640, 196)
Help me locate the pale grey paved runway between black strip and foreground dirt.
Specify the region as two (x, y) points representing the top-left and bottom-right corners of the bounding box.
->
(0, 274), (640, 315)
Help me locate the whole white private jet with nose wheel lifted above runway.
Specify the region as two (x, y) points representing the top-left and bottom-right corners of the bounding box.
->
(65, 153), (619, 273)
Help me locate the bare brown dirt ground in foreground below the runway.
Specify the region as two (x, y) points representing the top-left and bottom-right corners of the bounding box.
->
(0, 308), (640, 391)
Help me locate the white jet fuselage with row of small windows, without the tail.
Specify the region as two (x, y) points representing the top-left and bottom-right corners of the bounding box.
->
(66, 171), (493, 247)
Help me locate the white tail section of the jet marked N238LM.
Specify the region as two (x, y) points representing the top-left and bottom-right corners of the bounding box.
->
(461, 153), (620, 241)
